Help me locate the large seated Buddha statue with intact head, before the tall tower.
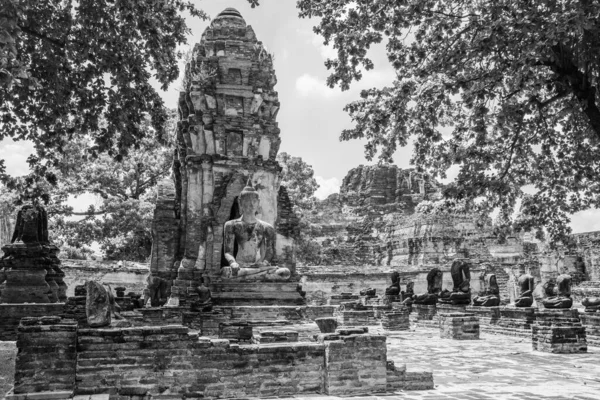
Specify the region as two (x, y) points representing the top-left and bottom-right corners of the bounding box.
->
(221, 185), (291, 281)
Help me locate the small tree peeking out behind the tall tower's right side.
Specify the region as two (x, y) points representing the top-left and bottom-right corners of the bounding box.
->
(277, 152), (319, 209)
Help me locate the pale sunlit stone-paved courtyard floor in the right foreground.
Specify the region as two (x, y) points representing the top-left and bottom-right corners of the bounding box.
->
(0, 324), (600, 400)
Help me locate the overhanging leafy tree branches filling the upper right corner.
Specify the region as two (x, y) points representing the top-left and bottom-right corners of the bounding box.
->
(298, 0), (600, 240)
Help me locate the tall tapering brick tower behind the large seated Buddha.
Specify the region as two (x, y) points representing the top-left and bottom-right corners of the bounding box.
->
(151, 9), (301, 303)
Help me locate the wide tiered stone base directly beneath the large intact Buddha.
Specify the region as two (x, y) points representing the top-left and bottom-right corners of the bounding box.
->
(208, 280), (306, 306)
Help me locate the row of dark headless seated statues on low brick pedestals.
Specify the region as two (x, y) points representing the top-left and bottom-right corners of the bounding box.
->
(385, 260), (584, 311)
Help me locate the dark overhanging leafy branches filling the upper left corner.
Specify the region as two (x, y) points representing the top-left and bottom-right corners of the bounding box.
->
(0, 0), (258, 195)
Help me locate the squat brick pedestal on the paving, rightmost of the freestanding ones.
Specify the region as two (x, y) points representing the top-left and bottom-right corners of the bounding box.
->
(531, 309), (587, 353)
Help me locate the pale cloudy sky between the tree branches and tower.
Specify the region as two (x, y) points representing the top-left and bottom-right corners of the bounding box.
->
(0, 0), (600, 232)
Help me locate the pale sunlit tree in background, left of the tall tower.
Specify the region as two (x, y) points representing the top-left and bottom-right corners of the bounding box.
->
(48, 111), (175, 261)
